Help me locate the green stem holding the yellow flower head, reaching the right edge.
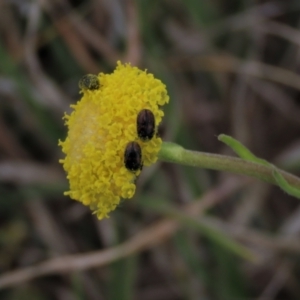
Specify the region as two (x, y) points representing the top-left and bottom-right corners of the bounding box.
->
(158, 142), (300, 188)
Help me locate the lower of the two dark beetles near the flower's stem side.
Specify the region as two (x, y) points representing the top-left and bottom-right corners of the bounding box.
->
(124, 142), (143, 172)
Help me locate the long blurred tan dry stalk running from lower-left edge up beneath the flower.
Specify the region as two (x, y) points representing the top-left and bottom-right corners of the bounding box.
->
(0, 180), (245, 288)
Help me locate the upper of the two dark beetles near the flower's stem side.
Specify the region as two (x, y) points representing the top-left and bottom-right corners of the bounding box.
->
(136, 109), (155, 141)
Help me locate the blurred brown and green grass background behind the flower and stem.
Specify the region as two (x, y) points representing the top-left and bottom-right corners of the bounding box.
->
(0, 0), (300, 300)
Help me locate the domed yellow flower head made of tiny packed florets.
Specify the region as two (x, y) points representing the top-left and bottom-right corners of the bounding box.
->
(59, 62), (169, 219)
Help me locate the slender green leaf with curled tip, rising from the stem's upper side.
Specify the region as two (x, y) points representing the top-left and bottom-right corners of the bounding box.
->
(218, 134), (272, 167)
